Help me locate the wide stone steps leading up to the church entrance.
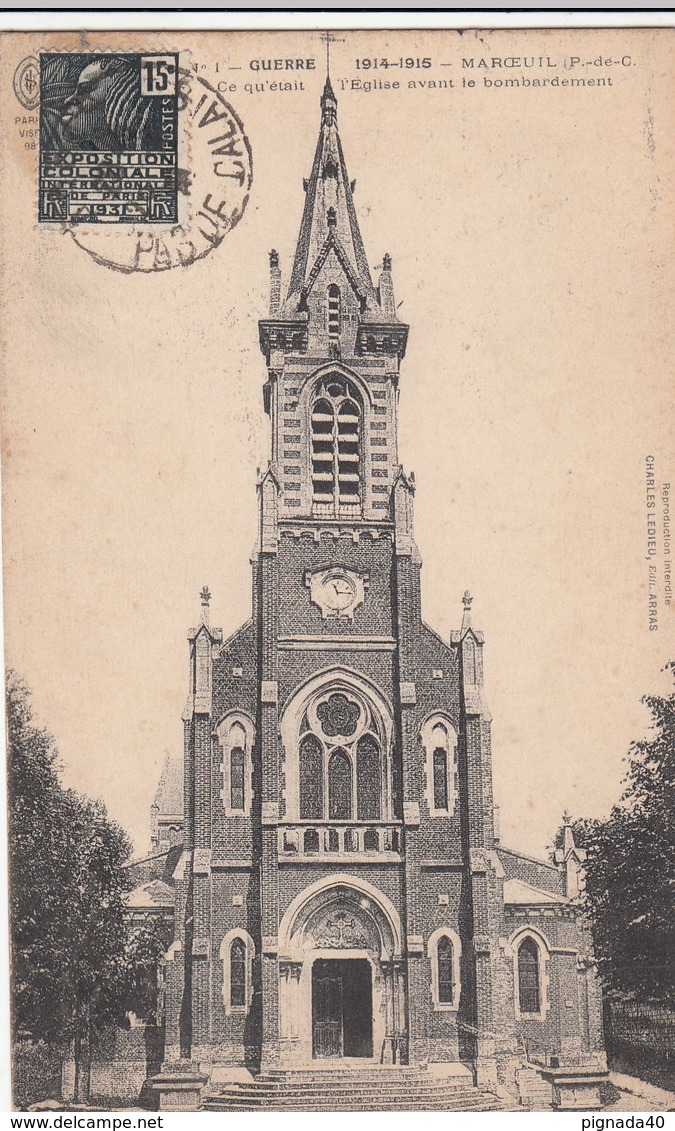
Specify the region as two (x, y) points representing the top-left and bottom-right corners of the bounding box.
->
(201, 1065), (507, 1112)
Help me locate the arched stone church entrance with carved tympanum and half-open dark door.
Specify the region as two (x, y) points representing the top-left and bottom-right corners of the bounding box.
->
(274, 875), (406, 1065)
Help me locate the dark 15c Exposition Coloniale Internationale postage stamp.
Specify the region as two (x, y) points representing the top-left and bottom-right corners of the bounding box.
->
(38, 53), (179, 224)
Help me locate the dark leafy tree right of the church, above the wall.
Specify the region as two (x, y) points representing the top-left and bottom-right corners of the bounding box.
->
(556, 664), (675, 1004)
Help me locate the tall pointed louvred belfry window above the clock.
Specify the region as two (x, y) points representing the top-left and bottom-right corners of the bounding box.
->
(311, 375), (362, 515)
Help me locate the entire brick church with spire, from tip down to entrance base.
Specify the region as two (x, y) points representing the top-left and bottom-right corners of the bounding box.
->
(157, 81), (605, 1103)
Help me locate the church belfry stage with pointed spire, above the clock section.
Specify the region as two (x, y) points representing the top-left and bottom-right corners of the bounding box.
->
(260, 79), (408, 523)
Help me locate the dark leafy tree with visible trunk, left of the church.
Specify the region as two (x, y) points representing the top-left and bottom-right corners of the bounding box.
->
(7, 672), (130, 1100)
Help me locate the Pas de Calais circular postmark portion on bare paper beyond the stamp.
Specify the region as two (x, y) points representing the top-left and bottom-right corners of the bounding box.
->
(60, 69), (253, 273)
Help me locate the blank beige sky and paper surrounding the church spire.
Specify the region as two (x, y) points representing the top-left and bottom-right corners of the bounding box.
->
(0, 29), (675, 853)
